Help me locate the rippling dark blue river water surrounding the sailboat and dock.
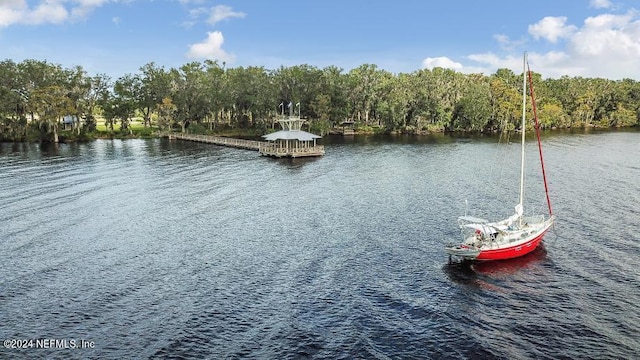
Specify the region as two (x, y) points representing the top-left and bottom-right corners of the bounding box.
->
(0, 132), (640, 359)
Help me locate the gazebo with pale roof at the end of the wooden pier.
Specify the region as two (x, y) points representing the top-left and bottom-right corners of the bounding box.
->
(258, 104), (324, 158)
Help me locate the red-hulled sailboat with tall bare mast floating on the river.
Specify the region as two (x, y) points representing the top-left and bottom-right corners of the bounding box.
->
(445, 53), (555, 261)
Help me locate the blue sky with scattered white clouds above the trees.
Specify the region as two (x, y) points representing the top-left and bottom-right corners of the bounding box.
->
(0, 0), (640, 80)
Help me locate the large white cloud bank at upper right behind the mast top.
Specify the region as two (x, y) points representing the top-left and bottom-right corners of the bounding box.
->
(456, 8), (640, 80)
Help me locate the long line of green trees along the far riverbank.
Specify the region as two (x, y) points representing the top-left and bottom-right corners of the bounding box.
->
(0, 59), (640, 142)
